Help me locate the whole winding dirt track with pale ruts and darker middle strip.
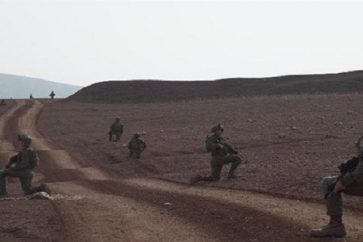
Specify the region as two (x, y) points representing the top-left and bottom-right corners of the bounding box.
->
(5, 99), (363, 241)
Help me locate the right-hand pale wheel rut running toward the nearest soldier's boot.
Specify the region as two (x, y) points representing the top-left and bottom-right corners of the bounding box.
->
(123, 178), (363, 242)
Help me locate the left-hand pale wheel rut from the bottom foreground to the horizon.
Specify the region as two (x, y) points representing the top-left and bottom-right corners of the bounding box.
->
(19, 101), (217, 241)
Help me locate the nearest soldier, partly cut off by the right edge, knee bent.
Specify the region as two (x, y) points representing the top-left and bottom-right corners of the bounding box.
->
(310, 136), (363, 238)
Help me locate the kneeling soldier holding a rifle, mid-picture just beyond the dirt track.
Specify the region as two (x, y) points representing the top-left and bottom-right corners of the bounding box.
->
(190, 124), (242, 184)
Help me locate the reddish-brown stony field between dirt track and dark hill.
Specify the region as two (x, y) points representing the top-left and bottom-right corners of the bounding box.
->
(38, 94), (363, 208)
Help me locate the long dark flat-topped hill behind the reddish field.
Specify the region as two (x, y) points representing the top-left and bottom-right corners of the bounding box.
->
(67, 71), (363, 103)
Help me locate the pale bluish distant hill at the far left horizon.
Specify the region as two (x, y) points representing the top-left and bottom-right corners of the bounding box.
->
(0, 73), (81, 98)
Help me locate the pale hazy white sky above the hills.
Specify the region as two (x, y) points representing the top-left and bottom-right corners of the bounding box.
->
(0, 0), (363, 86)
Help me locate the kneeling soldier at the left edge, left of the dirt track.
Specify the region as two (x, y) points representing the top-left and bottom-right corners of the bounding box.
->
(0, 135), (50, 195)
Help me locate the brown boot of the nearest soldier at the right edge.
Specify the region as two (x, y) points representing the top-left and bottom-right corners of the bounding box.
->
(310, 215), (347, 238)
